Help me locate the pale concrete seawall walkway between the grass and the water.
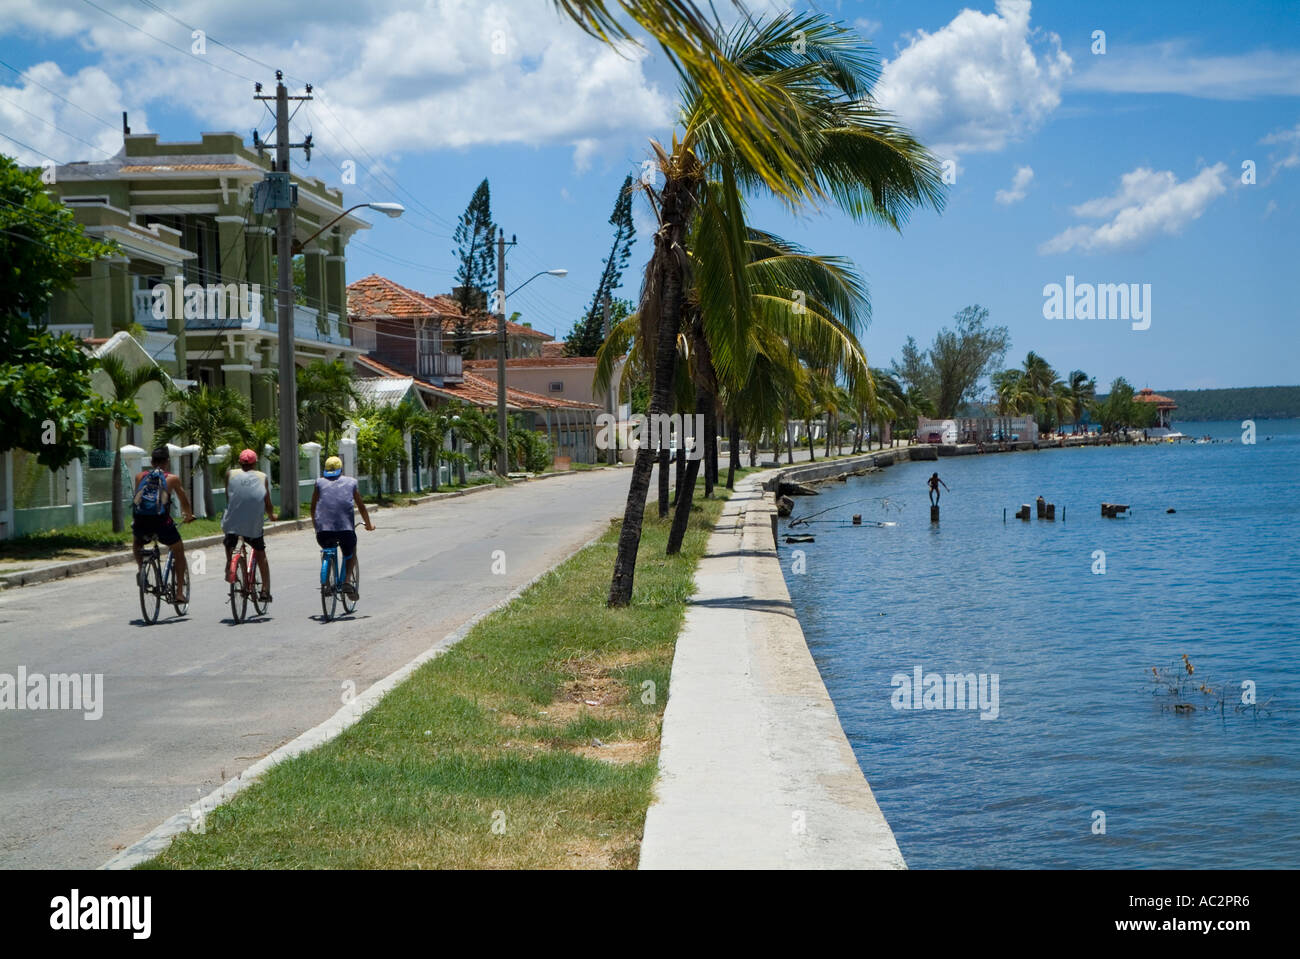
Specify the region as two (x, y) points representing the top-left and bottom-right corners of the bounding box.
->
(641, 474), (906, 869)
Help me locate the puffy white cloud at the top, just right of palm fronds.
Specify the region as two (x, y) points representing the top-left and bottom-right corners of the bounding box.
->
(876, 0), (1071, 157)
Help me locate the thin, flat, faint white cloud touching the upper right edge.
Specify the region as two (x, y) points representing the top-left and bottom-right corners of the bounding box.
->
(1070, 40), (1300, 100)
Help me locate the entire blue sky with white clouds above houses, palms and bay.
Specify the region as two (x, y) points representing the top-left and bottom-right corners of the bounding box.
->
(0, 0), (1300, 389)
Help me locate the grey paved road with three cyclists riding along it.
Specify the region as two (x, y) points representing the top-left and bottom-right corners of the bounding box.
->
(0, 470), (655, 868)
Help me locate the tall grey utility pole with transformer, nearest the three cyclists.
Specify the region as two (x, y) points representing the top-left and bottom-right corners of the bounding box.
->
(254, 70), (312, 520)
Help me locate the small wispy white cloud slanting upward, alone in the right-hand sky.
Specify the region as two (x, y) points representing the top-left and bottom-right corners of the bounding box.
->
(1039, 164), (1227, 253)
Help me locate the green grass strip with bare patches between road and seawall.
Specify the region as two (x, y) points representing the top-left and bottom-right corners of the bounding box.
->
(142, 475), (725, 868)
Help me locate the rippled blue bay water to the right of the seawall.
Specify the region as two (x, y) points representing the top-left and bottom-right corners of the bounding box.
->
(780, 420), (1300, 868)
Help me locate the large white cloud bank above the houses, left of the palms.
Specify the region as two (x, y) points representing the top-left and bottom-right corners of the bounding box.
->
(0, 0), (672, 168)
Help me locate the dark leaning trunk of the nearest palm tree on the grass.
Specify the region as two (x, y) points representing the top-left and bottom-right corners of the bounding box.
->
(607, 171), (692, 607)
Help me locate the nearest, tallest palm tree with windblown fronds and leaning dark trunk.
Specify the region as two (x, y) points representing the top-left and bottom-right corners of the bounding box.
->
(592, 7), (943, 606)
